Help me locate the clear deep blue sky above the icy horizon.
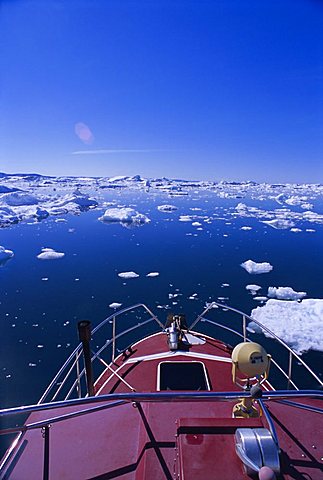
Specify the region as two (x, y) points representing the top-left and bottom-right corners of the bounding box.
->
(0, 0), (323, 182)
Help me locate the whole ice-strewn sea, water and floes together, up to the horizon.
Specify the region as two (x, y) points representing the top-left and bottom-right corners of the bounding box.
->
(0, 177), (323, 406)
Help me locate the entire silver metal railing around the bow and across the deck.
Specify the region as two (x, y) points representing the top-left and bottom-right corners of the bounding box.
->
(0, 302), (323, 479)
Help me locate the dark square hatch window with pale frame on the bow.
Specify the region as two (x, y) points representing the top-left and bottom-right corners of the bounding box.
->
(157, 362), (210, 391)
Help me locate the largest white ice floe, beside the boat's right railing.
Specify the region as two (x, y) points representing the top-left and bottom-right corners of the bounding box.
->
(249, 298), (323, 353)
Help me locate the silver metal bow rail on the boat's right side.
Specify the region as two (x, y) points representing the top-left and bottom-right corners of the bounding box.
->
(190, 302), (323, 388)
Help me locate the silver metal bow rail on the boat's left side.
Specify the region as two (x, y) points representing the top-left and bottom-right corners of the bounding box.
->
(38, 303), (164, 404)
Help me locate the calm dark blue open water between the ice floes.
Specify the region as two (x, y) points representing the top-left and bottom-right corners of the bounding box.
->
(0, 188), (323, 407)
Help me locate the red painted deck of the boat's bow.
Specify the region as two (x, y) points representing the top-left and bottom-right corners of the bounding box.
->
(0, 334), (323, 480)
